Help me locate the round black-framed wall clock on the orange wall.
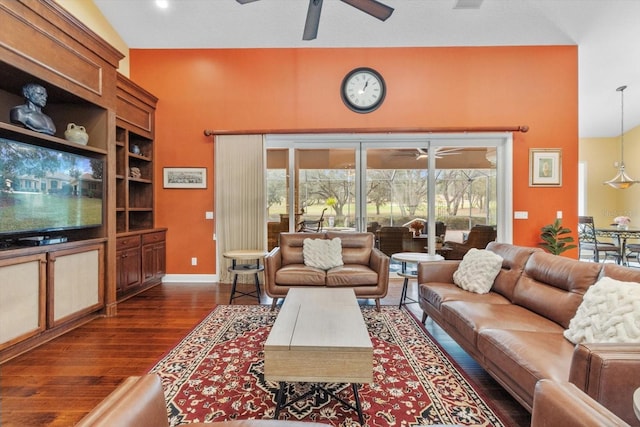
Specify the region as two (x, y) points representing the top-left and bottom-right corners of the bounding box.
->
(341, 67), (386, 113)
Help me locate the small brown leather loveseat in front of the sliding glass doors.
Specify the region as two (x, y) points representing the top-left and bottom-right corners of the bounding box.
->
(264, 231), (389, 309)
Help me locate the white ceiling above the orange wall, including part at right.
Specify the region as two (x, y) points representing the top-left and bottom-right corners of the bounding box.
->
(94, 0), (640, 137)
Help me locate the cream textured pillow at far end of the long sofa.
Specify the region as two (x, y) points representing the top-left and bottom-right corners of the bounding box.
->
(453, 248), (502, 294)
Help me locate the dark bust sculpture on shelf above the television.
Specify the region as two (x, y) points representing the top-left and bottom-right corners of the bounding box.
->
(9, 83), (56, 135)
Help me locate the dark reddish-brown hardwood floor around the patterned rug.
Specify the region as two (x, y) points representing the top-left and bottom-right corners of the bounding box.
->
(0, 280), (530, 427)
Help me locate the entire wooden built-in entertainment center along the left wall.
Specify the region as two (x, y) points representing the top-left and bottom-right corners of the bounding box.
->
(0, 0), (166, 363)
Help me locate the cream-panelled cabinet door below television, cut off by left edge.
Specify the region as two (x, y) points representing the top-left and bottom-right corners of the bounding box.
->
(0, 254), (47, 349)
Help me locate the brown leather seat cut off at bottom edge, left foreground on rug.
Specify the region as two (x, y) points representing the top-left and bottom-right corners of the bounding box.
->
(76, 374), (328, 427)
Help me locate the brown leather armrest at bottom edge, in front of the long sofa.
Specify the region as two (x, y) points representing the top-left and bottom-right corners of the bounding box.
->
(531, 379), (629, 427)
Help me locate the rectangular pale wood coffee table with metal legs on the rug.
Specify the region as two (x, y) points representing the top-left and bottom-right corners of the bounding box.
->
(264, 288), (373, 425)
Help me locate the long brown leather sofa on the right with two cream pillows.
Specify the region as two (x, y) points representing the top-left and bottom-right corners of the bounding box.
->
(418, 242), (640, 425)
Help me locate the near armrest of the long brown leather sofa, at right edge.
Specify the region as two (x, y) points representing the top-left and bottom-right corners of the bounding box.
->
(569, 343), (640, 425)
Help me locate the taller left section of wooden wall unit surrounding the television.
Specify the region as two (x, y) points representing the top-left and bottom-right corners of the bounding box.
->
(0, 0), (123, 363)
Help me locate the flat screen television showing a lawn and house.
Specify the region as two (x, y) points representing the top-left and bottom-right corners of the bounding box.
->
(0, 138), (105, 238)
